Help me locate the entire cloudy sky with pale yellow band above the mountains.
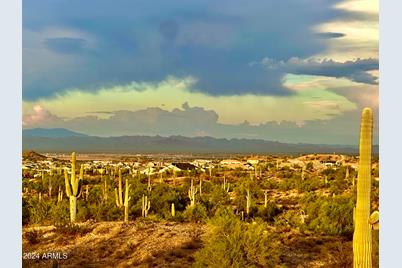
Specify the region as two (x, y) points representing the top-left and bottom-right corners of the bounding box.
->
(22, 0), (379, 144)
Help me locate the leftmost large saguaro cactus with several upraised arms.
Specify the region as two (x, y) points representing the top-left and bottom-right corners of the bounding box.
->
(64, 152), (84, 222)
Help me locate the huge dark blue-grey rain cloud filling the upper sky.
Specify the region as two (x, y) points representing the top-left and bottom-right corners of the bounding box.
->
(23, 0), (370, 100)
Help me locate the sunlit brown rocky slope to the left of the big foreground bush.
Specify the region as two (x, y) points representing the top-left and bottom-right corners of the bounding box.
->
(23, 221), (203, 267)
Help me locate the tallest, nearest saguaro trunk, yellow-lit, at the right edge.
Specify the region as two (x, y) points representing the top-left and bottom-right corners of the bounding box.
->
(353, 108), (373, 268)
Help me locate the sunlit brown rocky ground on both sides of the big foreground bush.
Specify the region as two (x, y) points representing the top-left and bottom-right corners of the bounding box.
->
(23, 220), (352, 267)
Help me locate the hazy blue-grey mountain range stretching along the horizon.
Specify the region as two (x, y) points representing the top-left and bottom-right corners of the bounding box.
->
(22, 128), (378, 154)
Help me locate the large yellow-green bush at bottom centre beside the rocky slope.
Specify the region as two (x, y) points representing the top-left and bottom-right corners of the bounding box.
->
(194, 209), (279, 267)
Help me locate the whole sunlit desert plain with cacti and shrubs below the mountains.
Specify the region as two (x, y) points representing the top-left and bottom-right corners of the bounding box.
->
(22, 108), (379, 267)
